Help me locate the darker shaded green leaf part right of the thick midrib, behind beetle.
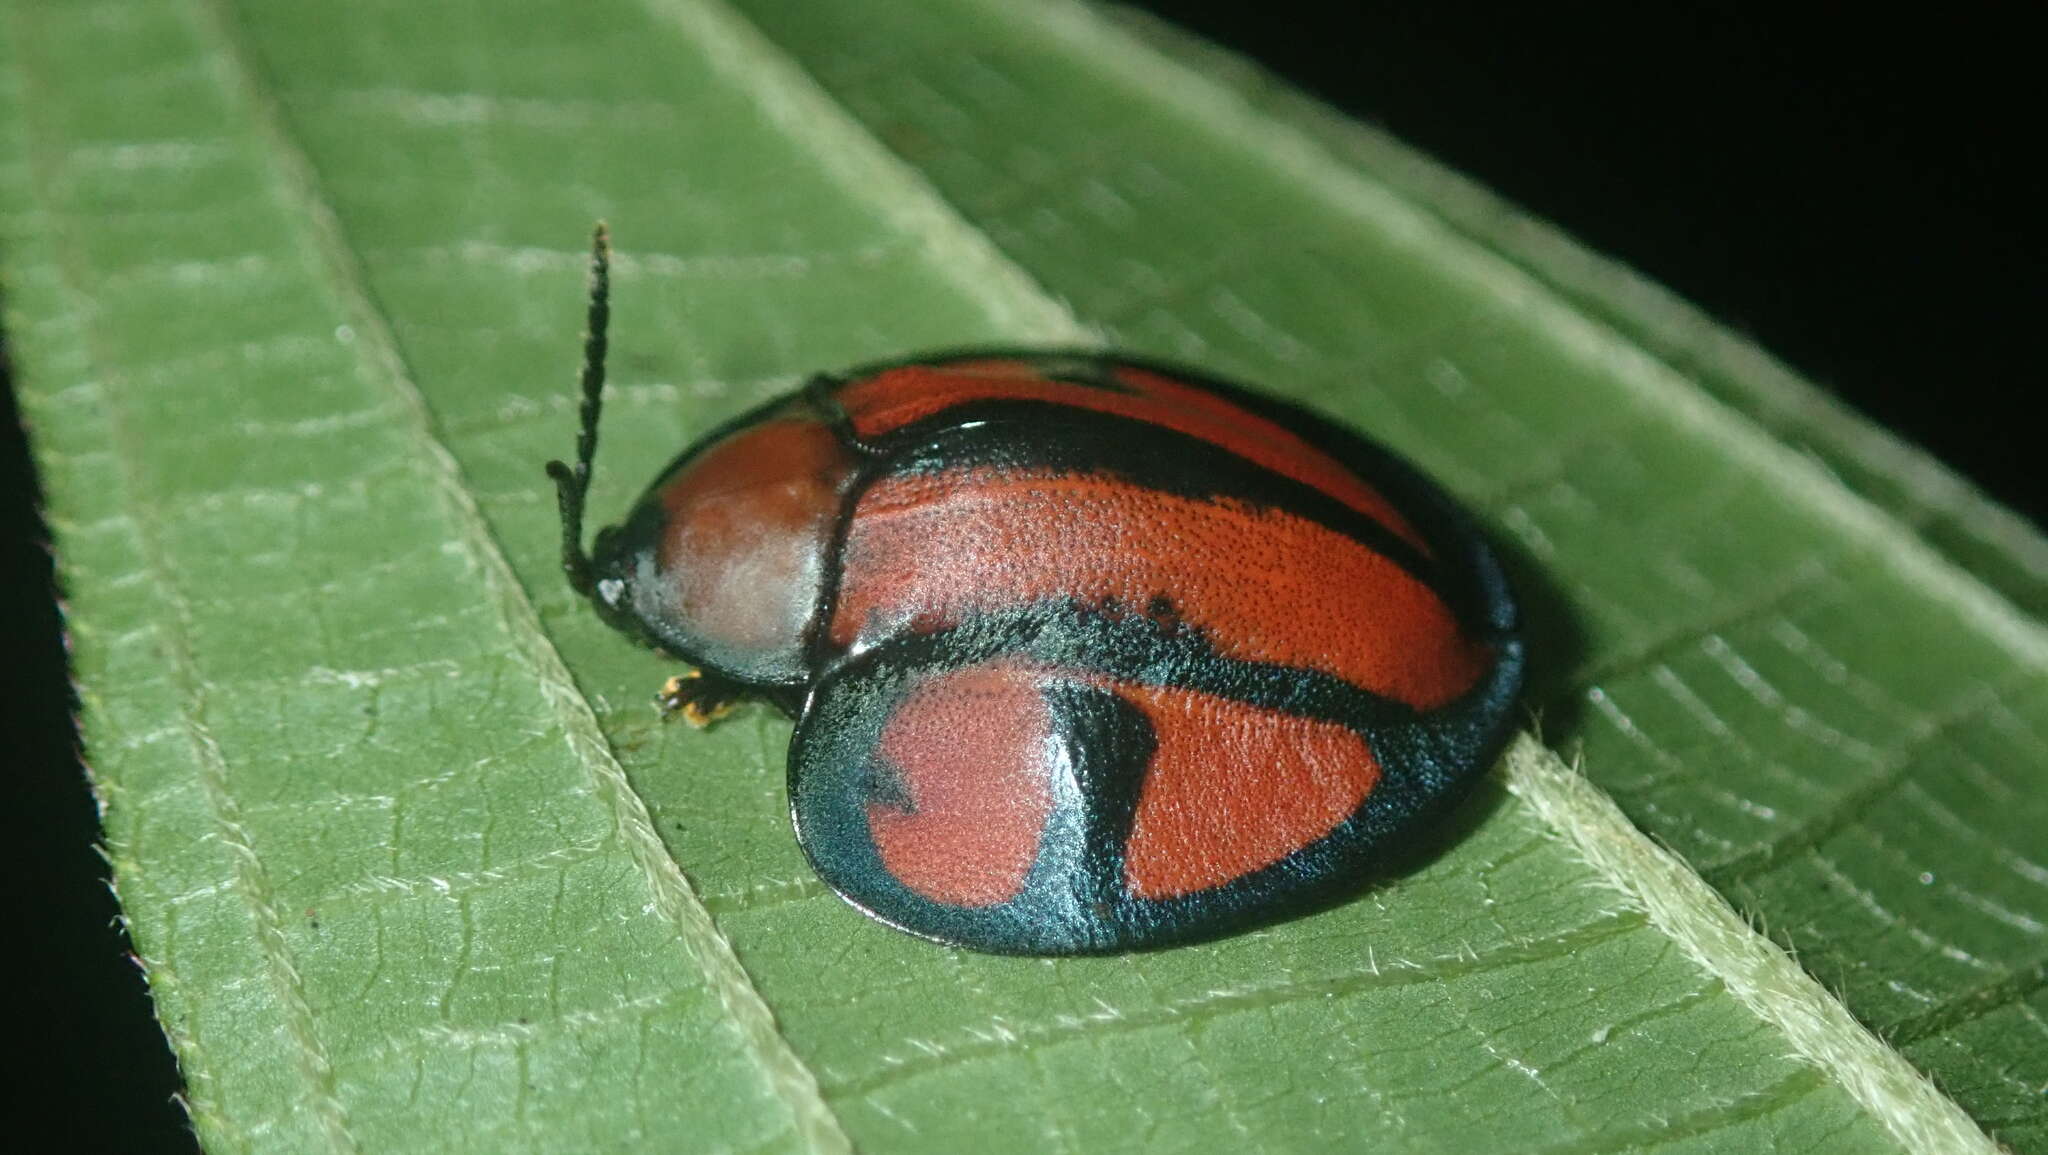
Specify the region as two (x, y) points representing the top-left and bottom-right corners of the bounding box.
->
(716, 0), (2048, 1145)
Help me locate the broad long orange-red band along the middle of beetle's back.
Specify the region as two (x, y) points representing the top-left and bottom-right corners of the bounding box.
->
(831, 469), (1493, 711)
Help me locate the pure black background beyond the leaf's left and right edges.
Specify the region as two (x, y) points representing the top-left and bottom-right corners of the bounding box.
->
(0, 0), (2042, 1151)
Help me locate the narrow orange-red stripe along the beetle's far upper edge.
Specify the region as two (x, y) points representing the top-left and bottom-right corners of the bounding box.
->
(838, 358), (1430, 555)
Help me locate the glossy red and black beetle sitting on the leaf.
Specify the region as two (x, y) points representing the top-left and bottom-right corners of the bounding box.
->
(547, 225), (1524, 954)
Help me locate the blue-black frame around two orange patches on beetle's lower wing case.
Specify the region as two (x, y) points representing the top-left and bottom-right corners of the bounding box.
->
(791, 606), (1522, 954)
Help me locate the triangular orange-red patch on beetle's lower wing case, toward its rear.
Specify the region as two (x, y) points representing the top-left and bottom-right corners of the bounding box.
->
(1116, 682), (1380, 899)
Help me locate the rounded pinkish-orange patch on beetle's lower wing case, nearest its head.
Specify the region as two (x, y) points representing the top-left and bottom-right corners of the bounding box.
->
(868, 664), (1053, 907)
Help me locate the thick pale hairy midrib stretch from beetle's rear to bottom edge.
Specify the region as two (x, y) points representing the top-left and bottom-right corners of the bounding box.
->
(1503, 735), (1997, 1153)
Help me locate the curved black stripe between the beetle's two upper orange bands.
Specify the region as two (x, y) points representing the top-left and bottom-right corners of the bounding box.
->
(877, 399), (1452, 604)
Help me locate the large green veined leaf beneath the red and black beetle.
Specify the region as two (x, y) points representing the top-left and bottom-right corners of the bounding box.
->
(0, 0), (2048, 1151)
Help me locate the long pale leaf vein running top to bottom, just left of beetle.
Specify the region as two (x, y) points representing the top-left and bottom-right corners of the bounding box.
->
(199, 0), (852, 1153)
